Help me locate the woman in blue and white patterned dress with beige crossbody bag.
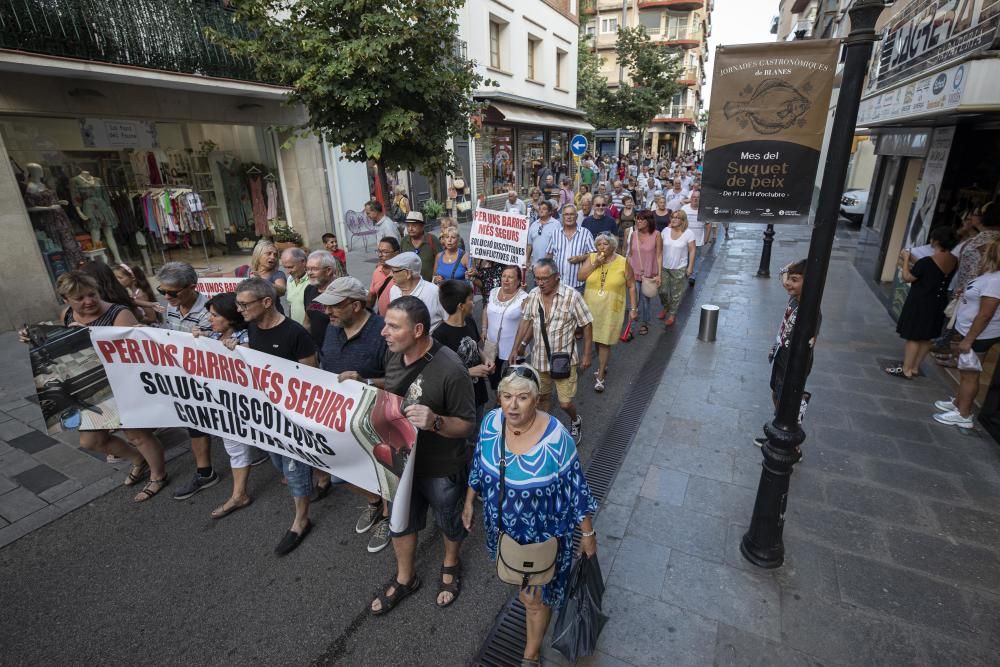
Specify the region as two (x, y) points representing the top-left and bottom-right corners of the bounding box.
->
(462, 366), (597, 667)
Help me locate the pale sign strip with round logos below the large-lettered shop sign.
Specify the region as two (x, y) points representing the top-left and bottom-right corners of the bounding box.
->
(858, 63), (971, 126)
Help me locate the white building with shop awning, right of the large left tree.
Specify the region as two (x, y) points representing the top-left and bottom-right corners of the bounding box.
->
(454, 0), (593, 206)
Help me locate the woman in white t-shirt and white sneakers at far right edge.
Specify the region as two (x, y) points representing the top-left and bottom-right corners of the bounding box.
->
(934, 241), (1000, 428)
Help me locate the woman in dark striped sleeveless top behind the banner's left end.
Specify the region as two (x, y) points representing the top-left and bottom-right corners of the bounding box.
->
(21, 271), (168, 503)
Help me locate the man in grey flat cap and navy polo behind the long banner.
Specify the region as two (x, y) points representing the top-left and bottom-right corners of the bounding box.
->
(314, 276), (389, 553)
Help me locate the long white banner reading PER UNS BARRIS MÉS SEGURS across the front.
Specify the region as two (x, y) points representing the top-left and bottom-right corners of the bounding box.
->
(91, 327), (417, 530)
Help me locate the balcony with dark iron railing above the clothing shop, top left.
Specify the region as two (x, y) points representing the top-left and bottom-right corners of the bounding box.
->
(0, 0), (263, 82)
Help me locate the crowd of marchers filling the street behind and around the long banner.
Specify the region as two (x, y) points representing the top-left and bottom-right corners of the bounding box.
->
(27, 154), (714, 665)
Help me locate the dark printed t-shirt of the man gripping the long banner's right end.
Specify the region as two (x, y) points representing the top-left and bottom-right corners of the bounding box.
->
(385, 341), (476, 477)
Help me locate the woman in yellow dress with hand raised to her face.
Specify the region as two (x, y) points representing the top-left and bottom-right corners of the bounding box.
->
(578, 232), (639, 393)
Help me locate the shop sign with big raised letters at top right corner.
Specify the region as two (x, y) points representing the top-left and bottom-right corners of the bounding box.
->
(868, 0), (1000, 90)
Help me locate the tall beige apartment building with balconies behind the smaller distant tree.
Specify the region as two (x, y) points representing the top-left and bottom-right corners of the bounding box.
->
(581, 0), (712, 157)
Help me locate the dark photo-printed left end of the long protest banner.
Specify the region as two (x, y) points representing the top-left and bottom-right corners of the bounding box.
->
(26, 324), (119, 435)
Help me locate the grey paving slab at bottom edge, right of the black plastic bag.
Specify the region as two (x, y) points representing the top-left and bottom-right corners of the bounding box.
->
(597, 585), (718, 667)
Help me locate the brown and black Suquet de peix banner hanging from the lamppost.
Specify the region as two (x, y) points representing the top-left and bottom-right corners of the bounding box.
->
(700, 39), (840, 223)
